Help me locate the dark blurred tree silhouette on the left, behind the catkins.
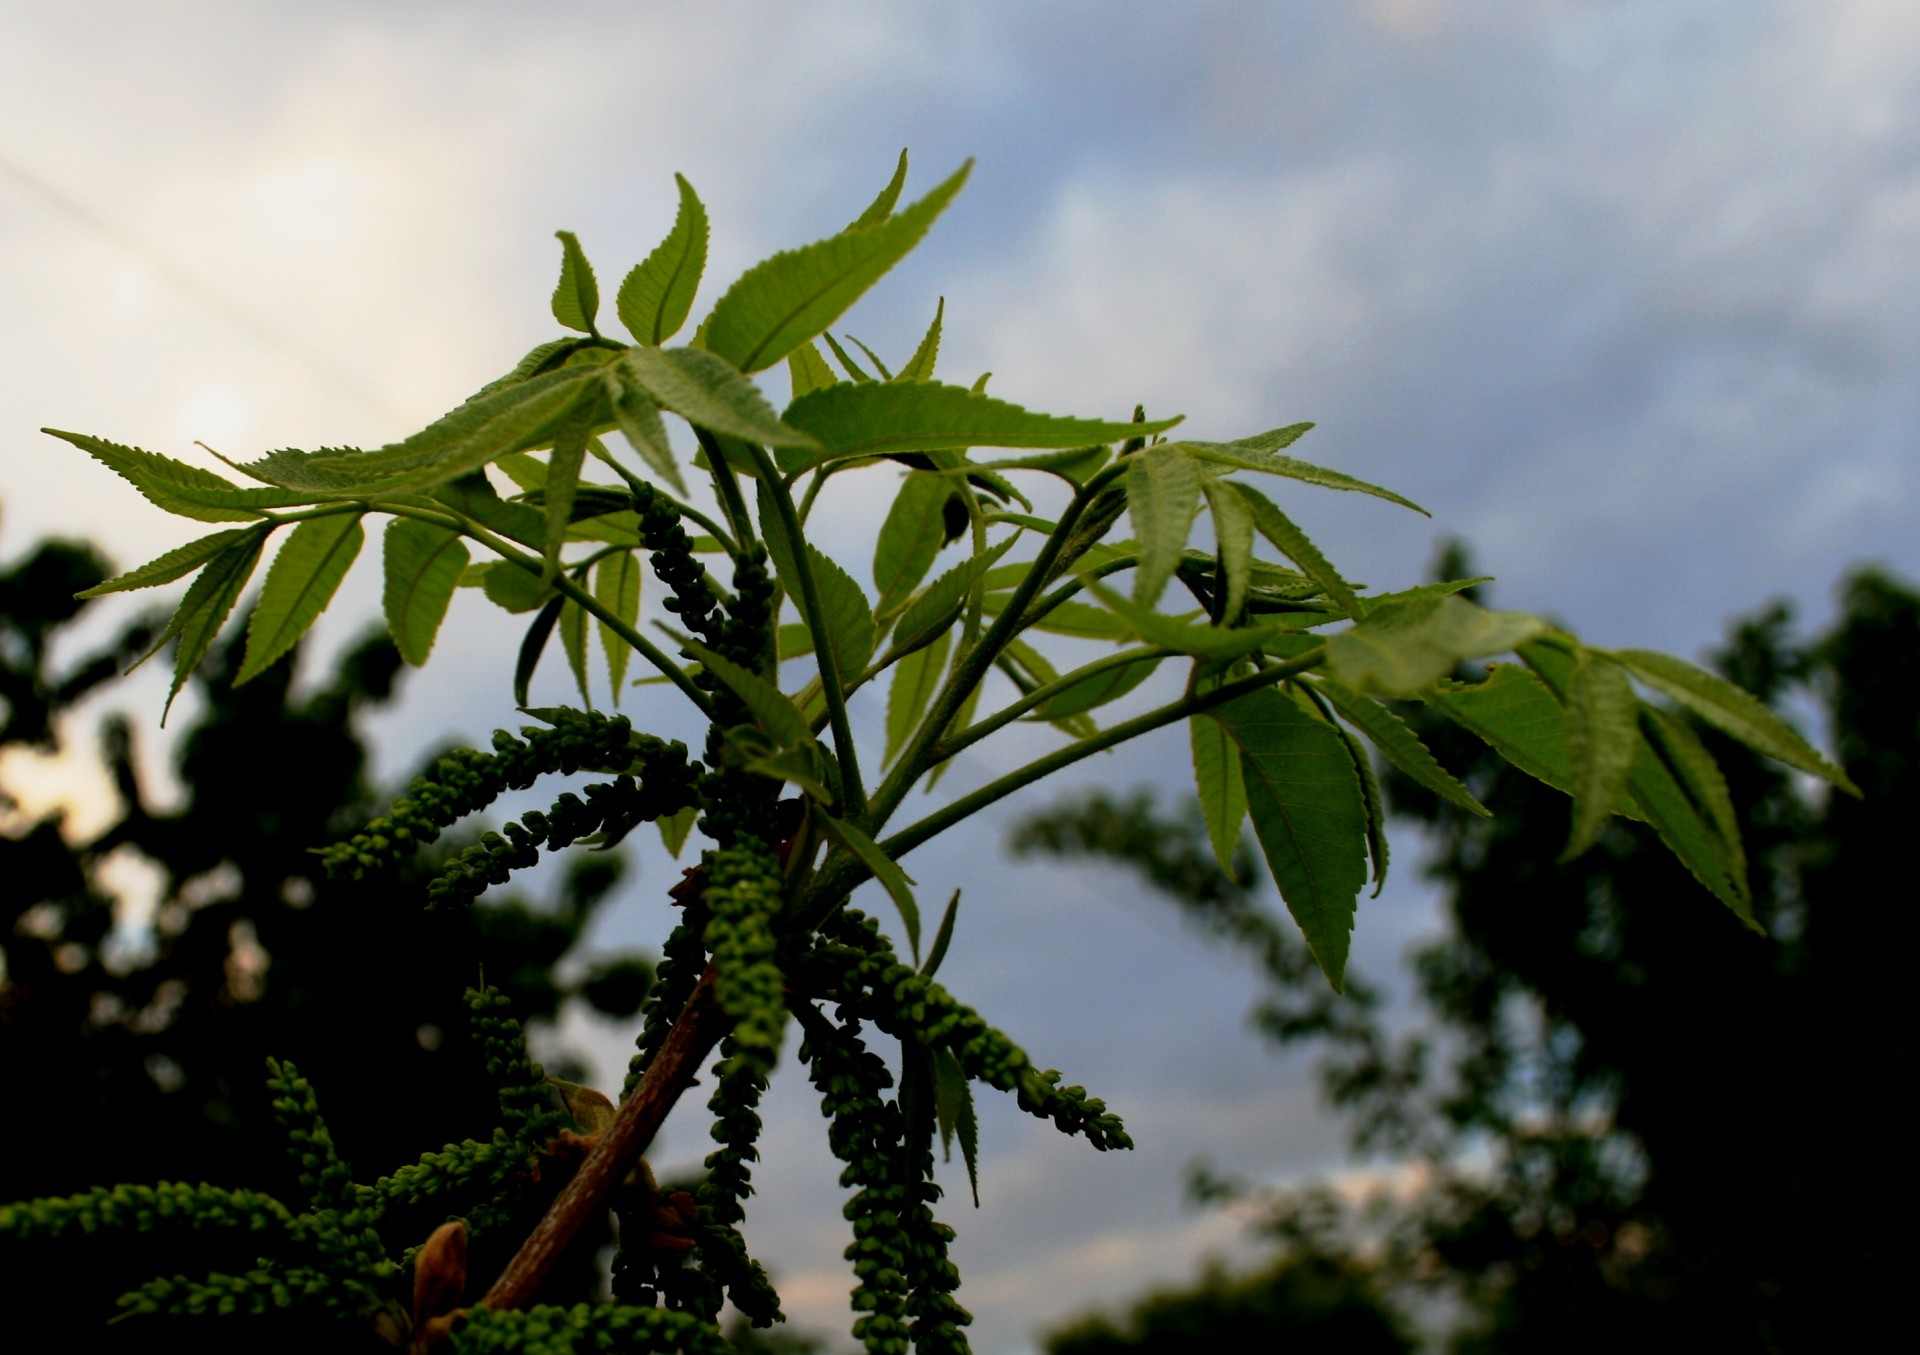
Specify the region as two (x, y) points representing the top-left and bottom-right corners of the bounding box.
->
(0, 529), (653, 1349)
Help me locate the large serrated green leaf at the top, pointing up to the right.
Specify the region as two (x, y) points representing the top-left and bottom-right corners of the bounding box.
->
(703, 161), (973, 372)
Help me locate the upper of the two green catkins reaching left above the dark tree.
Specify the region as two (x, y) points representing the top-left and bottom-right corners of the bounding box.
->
(321, 708), (660, 879)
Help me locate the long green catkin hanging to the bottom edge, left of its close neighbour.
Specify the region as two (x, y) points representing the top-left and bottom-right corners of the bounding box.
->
(799, 1011), (912, 1355)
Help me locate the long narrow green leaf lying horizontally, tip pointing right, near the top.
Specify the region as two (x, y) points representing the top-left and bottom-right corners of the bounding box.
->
(780, 382), (1179, 474)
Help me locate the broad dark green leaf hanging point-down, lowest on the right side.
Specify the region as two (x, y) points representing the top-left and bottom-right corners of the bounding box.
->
(1204, 689), (1367, 992)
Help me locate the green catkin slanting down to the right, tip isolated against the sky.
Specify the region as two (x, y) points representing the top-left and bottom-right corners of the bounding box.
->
(806, 908), (1133, 1152)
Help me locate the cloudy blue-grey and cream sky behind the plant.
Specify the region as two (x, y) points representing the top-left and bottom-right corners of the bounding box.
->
(0, 0), (1920, 1353)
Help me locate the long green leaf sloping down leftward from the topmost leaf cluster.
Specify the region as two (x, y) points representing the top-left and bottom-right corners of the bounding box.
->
(295, 367), (605, 499)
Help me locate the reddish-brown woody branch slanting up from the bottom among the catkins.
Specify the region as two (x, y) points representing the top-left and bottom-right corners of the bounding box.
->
(482, 965), (728, 1309)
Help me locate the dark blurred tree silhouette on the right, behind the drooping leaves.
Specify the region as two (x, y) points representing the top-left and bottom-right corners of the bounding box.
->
(1018, 559), (1920, 1355)
